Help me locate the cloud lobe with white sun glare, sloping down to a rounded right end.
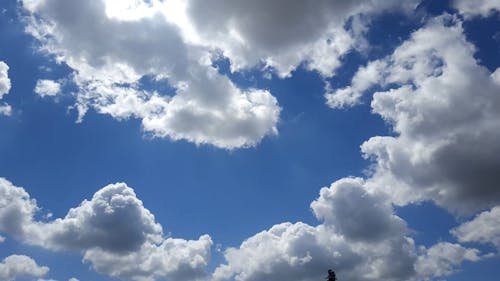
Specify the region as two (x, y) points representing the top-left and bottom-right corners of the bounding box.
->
(22, 0), (280, 149)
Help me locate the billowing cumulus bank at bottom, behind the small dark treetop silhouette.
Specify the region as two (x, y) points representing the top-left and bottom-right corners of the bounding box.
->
(213, 178), (480, 281)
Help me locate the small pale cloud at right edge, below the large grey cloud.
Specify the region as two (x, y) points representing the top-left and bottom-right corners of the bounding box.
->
(451, 206), (500, 249)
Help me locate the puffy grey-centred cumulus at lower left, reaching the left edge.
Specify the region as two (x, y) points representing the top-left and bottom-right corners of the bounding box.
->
(0, 179), (212, 281)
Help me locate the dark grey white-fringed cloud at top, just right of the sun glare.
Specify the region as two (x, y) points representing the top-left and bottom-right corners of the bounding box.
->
(186, 0), (416, 76)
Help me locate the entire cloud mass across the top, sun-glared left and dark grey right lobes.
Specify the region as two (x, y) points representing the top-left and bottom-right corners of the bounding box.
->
(21, 0), (424, 149)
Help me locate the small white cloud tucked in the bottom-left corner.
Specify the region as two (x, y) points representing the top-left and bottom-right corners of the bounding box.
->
(0, 255), (49, 281)
